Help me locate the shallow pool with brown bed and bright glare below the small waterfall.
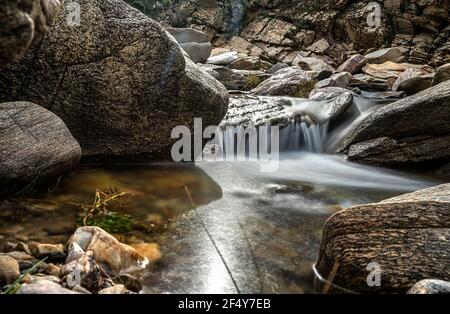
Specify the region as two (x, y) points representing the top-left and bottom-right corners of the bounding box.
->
(0, 153), (437, 293)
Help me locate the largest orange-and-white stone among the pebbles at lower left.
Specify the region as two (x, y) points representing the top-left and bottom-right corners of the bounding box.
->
(68, 227), (148, 275)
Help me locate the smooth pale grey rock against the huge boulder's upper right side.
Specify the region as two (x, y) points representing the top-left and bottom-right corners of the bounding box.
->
(166, 27), (212, 63)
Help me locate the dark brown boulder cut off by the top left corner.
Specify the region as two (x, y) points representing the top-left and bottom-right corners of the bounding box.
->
(0, 0), (62, 66)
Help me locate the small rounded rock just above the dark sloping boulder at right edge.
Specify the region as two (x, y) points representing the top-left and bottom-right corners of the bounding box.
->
(392, 68), (434, 95)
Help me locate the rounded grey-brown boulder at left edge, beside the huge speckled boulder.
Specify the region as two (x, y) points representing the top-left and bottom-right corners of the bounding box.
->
(0, 102), (81, 194)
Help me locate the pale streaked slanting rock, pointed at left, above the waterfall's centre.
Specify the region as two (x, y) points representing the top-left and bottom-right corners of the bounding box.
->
(252, 66), (313, 96)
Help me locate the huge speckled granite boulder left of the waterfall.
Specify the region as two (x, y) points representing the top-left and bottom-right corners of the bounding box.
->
(0, 0), (228, 162)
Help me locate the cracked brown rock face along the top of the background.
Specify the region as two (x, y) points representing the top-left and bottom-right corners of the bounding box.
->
(146, 0), (450, 65)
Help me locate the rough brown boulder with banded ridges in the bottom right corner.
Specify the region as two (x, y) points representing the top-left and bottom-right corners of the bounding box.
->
(316, 184), (450, 293)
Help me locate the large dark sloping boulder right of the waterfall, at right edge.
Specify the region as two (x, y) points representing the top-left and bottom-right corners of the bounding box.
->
(340, 81), (450, 165)
